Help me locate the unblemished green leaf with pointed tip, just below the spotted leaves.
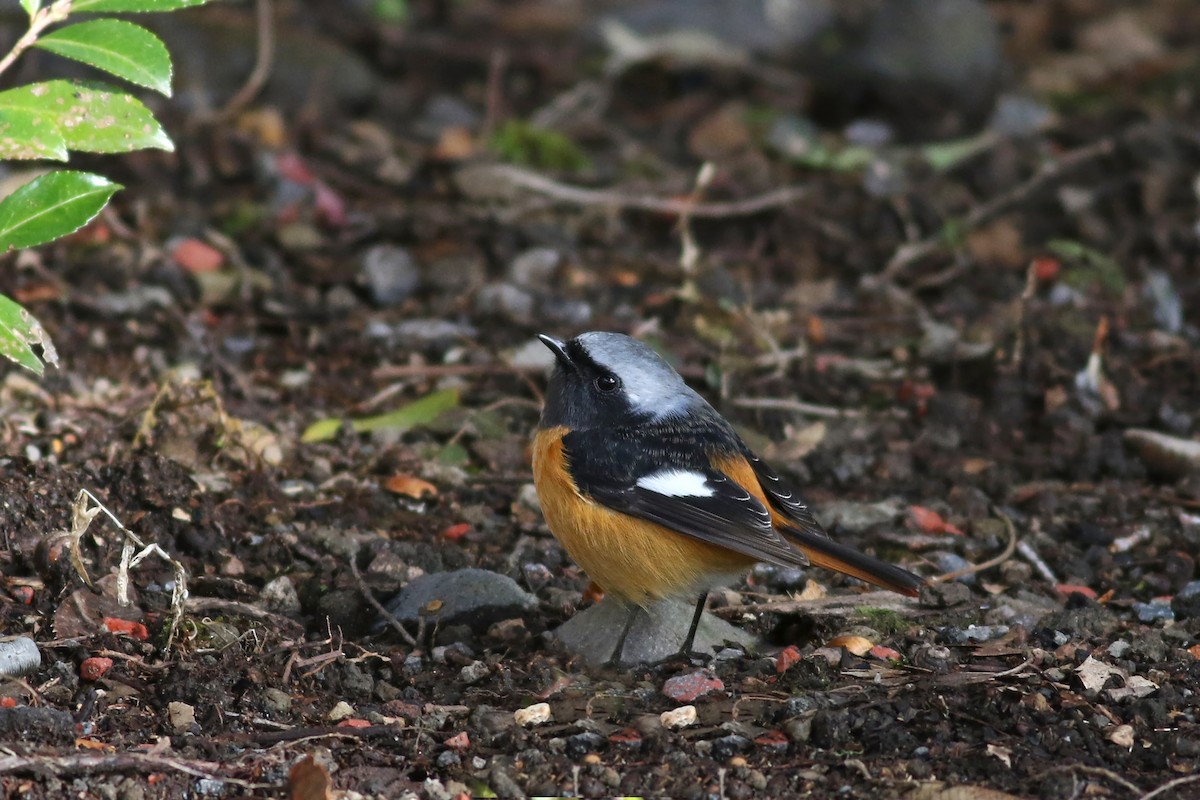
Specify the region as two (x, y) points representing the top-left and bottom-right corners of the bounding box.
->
(0, 170), (121, 253)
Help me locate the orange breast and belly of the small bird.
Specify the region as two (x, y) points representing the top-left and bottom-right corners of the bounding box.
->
(533, 428), (755, 606)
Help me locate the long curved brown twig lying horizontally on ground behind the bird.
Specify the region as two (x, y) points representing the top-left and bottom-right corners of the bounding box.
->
(488, 164), (808, 219)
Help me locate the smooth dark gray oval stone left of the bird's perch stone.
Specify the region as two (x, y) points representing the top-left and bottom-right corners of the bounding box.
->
(388, 569), (538, 633)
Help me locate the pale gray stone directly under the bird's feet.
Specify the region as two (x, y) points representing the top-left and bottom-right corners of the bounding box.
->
(553, 597), (756, 667)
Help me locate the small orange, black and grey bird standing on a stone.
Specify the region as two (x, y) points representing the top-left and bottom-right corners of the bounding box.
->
(533, 331), (924, 663)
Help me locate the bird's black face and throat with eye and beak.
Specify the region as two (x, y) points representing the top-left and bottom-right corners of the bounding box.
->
(538, 336), (646, 431)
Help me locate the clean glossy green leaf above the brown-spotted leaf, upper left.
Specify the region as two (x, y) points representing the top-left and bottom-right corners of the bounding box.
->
(36, 19), (170, 97)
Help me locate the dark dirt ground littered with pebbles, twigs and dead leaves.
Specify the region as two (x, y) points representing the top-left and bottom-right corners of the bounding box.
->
(0, 0), (1200, 800)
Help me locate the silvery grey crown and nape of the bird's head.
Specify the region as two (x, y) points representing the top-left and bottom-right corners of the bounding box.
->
(576, 331), (704, 419)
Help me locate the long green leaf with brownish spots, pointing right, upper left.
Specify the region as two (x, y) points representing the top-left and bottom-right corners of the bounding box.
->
(0, 80), (175, 152)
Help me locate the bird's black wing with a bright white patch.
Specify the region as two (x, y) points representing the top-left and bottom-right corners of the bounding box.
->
(563, 425), (808, 566)
